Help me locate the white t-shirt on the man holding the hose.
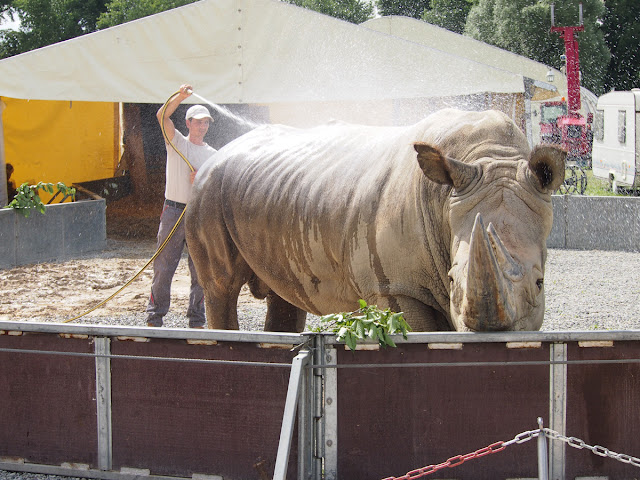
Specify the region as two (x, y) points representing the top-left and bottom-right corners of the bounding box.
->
(164, 130), (217, 203)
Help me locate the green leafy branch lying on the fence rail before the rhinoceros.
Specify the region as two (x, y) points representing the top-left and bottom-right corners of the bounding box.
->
(316, 299), (411, 350)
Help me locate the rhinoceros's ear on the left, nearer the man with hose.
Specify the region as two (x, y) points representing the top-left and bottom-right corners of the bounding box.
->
(413, 142), (480, 191)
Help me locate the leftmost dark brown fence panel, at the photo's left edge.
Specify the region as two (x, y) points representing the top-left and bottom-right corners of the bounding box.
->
(0, 333), (97, 467)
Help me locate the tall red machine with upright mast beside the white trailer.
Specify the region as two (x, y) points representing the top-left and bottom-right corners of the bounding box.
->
(540, 3), (593, 167)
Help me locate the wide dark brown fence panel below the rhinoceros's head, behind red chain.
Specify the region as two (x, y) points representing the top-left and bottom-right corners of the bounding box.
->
(338, 343), (549, 480)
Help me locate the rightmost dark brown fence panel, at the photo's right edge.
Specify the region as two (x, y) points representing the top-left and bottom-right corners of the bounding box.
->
(566, 342), (640, 480)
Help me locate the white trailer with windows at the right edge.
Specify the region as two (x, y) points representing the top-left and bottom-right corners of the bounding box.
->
(592, 88), (640, 191)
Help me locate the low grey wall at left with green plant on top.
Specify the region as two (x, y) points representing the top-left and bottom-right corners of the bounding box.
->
(0, 199), (107, 268)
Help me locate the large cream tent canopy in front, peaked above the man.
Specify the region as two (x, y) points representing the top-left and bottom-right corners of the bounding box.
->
(0, 0), (524, 103)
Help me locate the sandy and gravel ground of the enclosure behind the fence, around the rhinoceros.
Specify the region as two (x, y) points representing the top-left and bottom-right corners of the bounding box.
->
(0, 238), (640, 331)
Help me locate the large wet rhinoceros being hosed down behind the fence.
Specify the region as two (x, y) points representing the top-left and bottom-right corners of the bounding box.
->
(186, 109), (565, 331)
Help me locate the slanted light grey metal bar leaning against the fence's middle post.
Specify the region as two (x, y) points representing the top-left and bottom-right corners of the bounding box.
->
(273, 350), (311, 480)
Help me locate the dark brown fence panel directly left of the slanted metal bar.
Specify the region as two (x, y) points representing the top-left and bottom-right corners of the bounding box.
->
(111, 339), (297, 480)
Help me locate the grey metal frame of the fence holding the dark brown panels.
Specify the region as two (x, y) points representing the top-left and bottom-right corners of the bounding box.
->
(0, 321), (640, 480)
